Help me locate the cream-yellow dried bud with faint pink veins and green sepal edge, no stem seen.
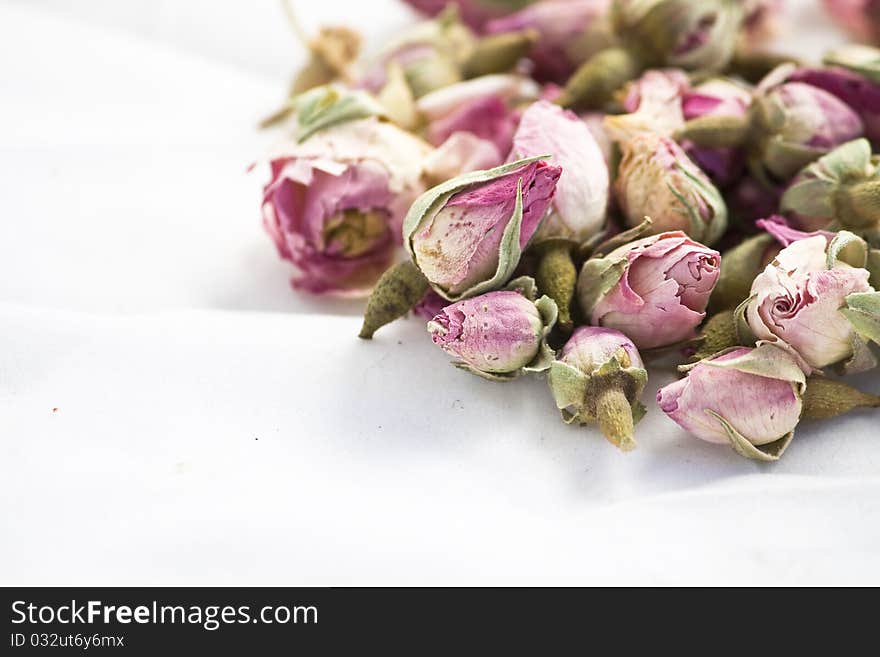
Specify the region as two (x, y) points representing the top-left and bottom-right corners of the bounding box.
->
(614, 134), (727, 244)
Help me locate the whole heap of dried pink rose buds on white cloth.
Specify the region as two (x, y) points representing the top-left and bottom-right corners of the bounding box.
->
(262, 0), (880, 461)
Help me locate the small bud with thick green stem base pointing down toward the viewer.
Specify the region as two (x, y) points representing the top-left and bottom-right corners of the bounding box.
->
(548, 326), (648, 451)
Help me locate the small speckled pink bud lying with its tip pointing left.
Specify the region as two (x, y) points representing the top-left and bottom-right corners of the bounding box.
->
(428, 277), (556, 381)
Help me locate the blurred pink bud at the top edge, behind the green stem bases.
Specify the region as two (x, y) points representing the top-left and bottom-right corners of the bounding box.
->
(486, 0), (612, 84)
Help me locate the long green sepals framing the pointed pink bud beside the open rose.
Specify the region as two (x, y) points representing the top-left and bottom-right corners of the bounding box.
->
(403, 155), (550, 301)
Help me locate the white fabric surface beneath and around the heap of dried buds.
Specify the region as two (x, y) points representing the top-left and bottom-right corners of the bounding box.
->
(0, 0), (880, 585)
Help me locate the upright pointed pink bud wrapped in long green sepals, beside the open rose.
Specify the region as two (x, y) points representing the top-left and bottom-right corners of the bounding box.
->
(404, 158), (562, 301)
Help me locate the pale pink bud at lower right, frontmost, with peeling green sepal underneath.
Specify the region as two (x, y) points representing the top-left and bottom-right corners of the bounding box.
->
(657, 345), (806, 461)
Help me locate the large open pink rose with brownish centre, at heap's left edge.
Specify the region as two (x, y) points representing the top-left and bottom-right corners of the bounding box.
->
(262, 119), (430, 295)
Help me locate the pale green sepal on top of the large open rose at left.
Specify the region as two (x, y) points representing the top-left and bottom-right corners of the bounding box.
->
(292, 85), (386, 143)
